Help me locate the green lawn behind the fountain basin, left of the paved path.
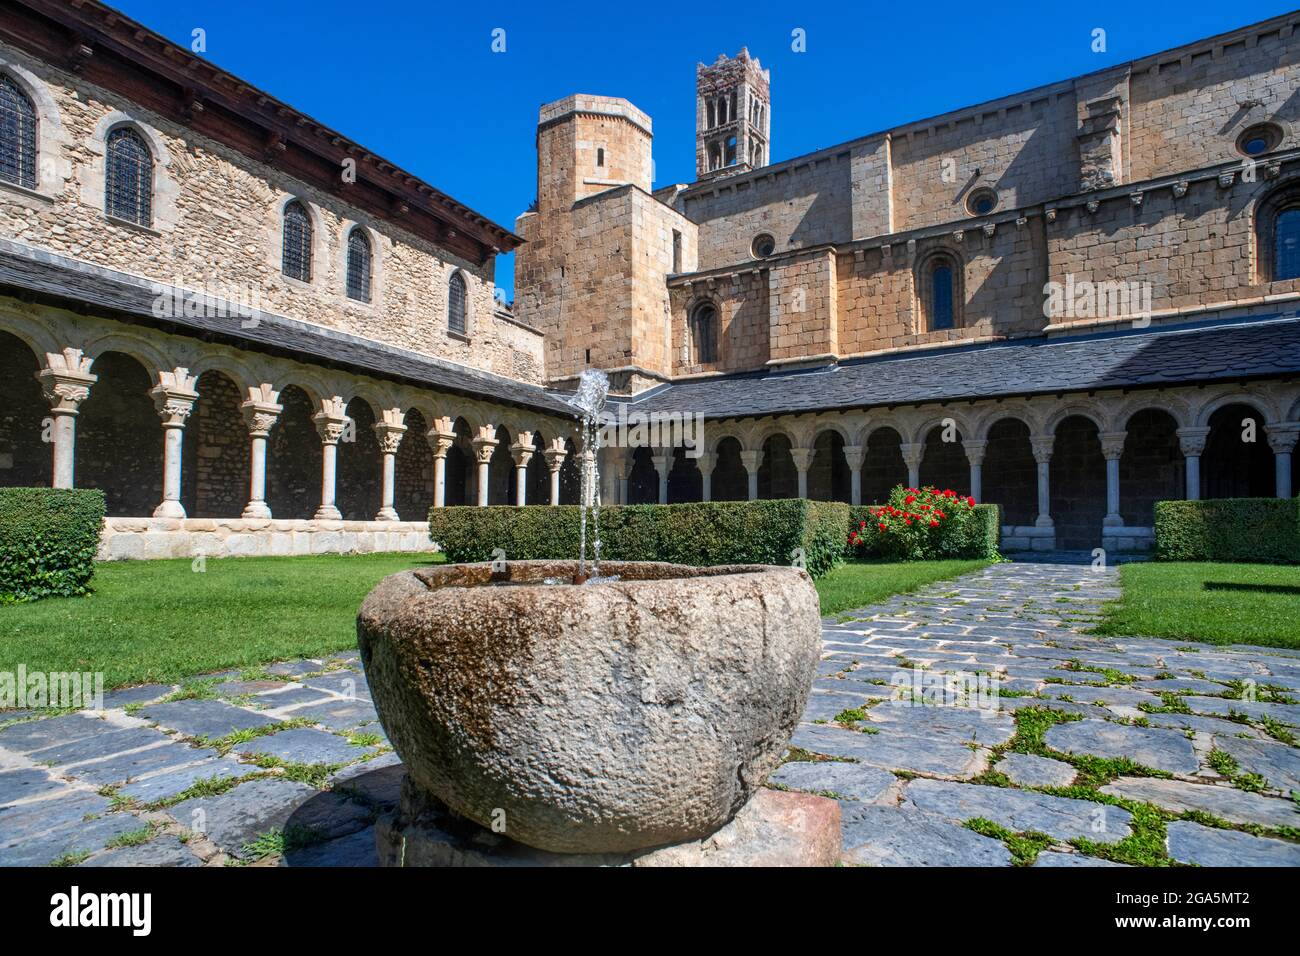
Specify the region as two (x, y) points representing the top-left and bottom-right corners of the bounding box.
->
(0, 554), (988, 688)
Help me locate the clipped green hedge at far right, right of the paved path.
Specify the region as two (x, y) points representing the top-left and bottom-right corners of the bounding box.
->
(1156, 498), (1300, 564)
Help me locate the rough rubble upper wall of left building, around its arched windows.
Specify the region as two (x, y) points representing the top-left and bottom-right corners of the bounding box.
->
(0, 37), (541, 381)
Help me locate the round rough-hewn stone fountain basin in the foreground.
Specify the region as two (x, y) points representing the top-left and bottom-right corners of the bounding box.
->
(358, 561), (820, 853)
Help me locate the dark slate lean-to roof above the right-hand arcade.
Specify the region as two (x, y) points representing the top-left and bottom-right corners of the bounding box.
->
(616, 312), (1300, 418)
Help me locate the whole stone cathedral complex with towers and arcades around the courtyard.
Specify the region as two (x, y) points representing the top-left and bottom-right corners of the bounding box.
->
(0, 0), (1300, 557)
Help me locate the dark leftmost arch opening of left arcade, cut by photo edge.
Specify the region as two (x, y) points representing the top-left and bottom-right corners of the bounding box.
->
(0, 332), (53, 488)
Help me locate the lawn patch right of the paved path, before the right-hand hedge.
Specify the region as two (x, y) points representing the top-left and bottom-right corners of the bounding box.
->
(1096, 561), (1300, 648)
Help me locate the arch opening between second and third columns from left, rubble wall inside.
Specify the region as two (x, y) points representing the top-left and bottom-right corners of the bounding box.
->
(181, 368), (251, 518)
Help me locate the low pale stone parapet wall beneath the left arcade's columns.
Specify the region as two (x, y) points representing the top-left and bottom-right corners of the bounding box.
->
(98, 518), (438, 561)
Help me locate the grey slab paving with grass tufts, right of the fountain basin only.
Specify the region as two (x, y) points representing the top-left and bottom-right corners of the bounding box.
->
(790, 563), (1300, 866)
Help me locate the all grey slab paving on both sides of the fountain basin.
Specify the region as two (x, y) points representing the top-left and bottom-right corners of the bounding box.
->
(0, 563), (1300, 866)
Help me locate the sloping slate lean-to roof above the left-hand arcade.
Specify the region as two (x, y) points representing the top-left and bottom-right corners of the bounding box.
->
(0, 239), (573, 415)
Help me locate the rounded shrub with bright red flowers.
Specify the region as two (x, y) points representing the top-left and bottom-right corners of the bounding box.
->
(849, 485), (984, 561)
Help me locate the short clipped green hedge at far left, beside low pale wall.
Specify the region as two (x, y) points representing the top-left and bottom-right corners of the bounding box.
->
(0, 488), (104, 604)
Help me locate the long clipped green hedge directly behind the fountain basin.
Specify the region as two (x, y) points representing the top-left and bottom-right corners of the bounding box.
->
(429, 498), (849, 578)
